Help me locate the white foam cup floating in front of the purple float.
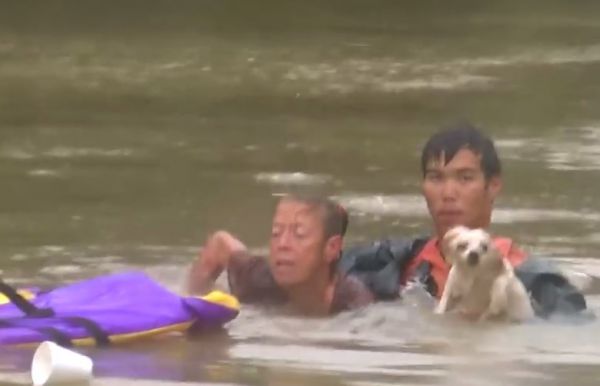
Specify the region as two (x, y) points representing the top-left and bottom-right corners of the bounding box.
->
(31, 341), (93, 386)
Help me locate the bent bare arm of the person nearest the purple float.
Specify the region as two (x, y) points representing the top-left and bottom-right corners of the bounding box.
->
(187, 231), (247, 294)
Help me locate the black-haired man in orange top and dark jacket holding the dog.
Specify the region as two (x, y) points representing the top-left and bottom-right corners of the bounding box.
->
(339, 124), (586, 316)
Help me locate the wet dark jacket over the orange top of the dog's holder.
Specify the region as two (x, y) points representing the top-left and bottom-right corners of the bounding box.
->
(338, 238), (589, 318)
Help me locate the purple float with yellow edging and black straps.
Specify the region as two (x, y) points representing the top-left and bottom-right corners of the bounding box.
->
(0, 272), (239, 346)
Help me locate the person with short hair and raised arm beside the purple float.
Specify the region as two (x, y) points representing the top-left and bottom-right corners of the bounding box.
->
(188, 195), (373, 315)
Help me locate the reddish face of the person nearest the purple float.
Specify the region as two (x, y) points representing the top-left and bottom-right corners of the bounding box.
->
(269, 200), (330, 288)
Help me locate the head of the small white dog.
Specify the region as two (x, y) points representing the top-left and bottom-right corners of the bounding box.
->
(441, 226), (501, 269)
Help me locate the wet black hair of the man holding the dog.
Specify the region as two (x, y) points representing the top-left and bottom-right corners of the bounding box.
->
(421, 122), (502, 180)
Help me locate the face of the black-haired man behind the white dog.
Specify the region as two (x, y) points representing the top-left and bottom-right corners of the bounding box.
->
(422, 149), (502, 237)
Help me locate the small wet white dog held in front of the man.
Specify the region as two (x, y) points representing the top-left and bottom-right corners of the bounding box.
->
(435, 226), (534, 321)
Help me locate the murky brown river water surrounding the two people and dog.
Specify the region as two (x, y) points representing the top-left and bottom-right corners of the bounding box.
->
(0, 0), (600, 386)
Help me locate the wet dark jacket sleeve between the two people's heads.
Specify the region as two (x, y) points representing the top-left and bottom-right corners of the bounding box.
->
(338, 239), (426, 300)
